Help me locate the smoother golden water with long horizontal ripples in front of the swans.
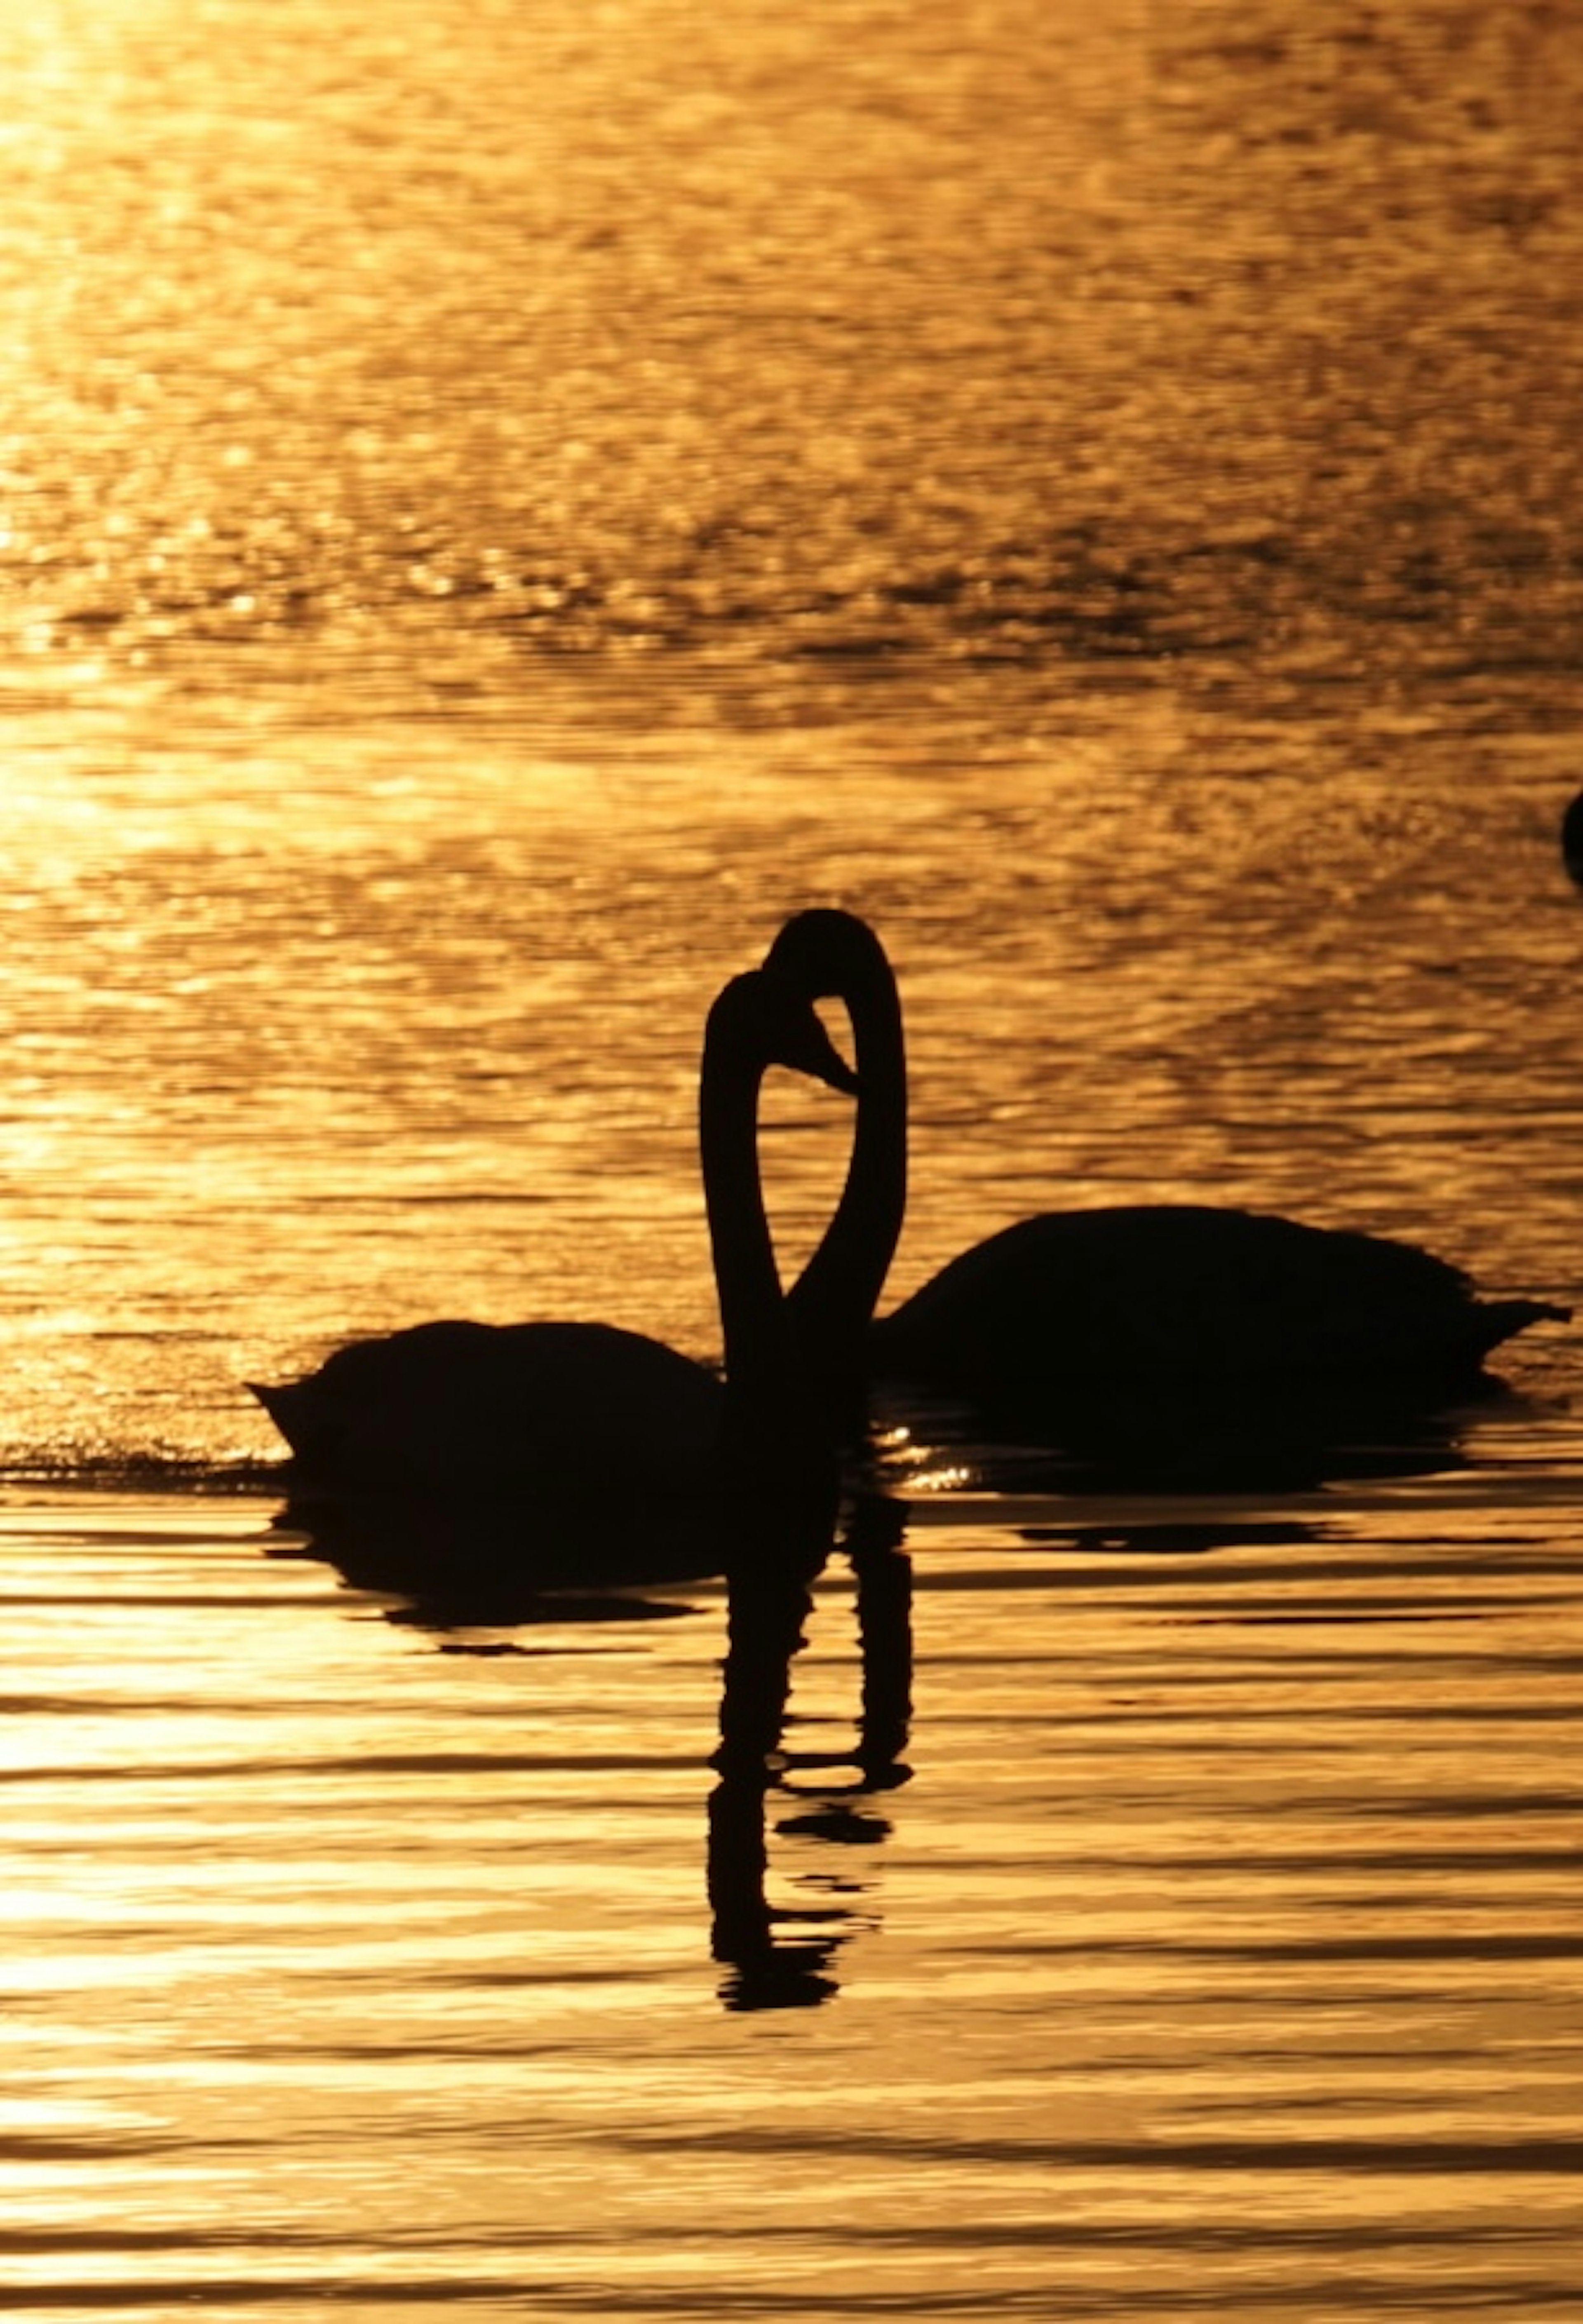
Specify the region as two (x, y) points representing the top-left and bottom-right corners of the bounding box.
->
(0, 1459), (1583, 2324)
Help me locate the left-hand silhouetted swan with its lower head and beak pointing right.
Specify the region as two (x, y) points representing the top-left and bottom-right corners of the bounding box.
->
(247, 969), (860, 1492)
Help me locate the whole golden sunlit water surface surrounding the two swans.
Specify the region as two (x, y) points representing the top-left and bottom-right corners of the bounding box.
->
(0, 0), (1583, 2324)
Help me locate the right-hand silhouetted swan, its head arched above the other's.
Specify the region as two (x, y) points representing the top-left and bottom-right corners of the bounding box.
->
(767, 911), (1569, 1408)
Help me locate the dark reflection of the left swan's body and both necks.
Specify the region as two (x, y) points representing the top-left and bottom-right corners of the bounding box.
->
(270, 1492), (911, 2010)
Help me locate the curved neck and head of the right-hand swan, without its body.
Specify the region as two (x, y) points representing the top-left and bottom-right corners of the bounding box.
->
(769, 911), (907, 1371)
